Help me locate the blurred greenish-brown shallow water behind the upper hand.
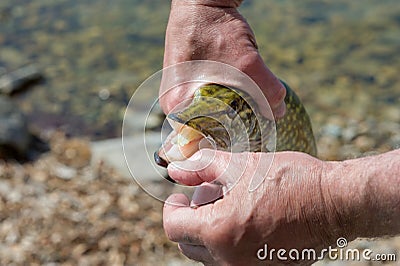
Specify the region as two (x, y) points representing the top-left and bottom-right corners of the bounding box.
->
(0, 0), (400, 139)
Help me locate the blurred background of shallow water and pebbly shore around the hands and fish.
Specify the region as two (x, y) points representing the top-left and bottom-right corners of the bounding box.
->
(0, 0), (400, 265)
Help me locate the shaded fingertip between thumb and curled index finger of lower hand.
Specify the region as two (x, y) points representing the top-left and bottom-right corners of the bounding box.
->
(190, 183), (223, 208)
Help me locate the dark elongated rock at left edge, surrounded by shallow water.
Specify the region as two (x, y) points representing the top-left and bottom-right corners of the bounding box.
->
(0, 65), (43, 95)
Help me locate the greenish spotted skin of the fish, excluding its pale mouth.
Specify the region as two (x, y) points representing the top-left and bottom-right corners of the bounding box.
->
(168, 82), (317, 156)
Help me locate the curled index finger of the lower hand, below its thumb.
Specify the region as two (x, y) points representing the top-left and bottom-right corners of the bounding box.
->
(163, 194), (207, 245)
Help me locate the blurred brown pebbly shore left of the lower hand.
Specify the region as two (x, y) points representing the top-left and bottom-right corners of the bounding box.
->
(0, 133), (197, 265)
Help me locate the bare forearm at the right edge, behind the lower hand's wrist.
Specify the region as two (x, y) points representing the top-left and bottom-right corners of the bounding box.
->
(321, 149), (400, 241)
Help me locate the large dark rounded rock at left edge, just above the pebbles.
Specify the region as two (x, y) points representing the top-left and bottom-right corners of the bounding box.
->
(0, 96), (32, 158)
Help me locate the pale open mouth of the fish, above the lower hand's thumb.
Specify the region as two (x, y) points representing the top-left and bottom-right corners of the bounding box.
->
(154, 117), (215, 167)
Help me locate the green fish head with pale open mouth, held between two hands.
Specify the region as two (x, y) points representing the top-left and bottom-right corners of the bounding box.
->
(155, 84), (261, 167)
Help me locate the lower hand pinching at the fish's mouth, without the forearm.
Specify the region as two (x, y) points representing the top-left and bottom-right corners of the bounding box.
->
(164, 150), (350, 265)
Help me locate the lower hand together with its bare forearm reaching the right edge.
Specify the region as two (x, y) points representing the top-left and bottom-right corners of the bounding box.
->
(163, 149), (400, 265)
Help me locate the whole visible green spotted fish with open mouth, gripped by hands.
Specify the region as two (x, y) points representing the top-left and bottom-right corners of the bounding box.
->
(154, 81), (317, 167)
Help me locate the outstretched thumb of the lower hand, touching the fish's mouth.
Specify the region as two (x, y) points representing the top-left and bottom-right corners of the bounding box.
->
(168, 149), (232, 186)
